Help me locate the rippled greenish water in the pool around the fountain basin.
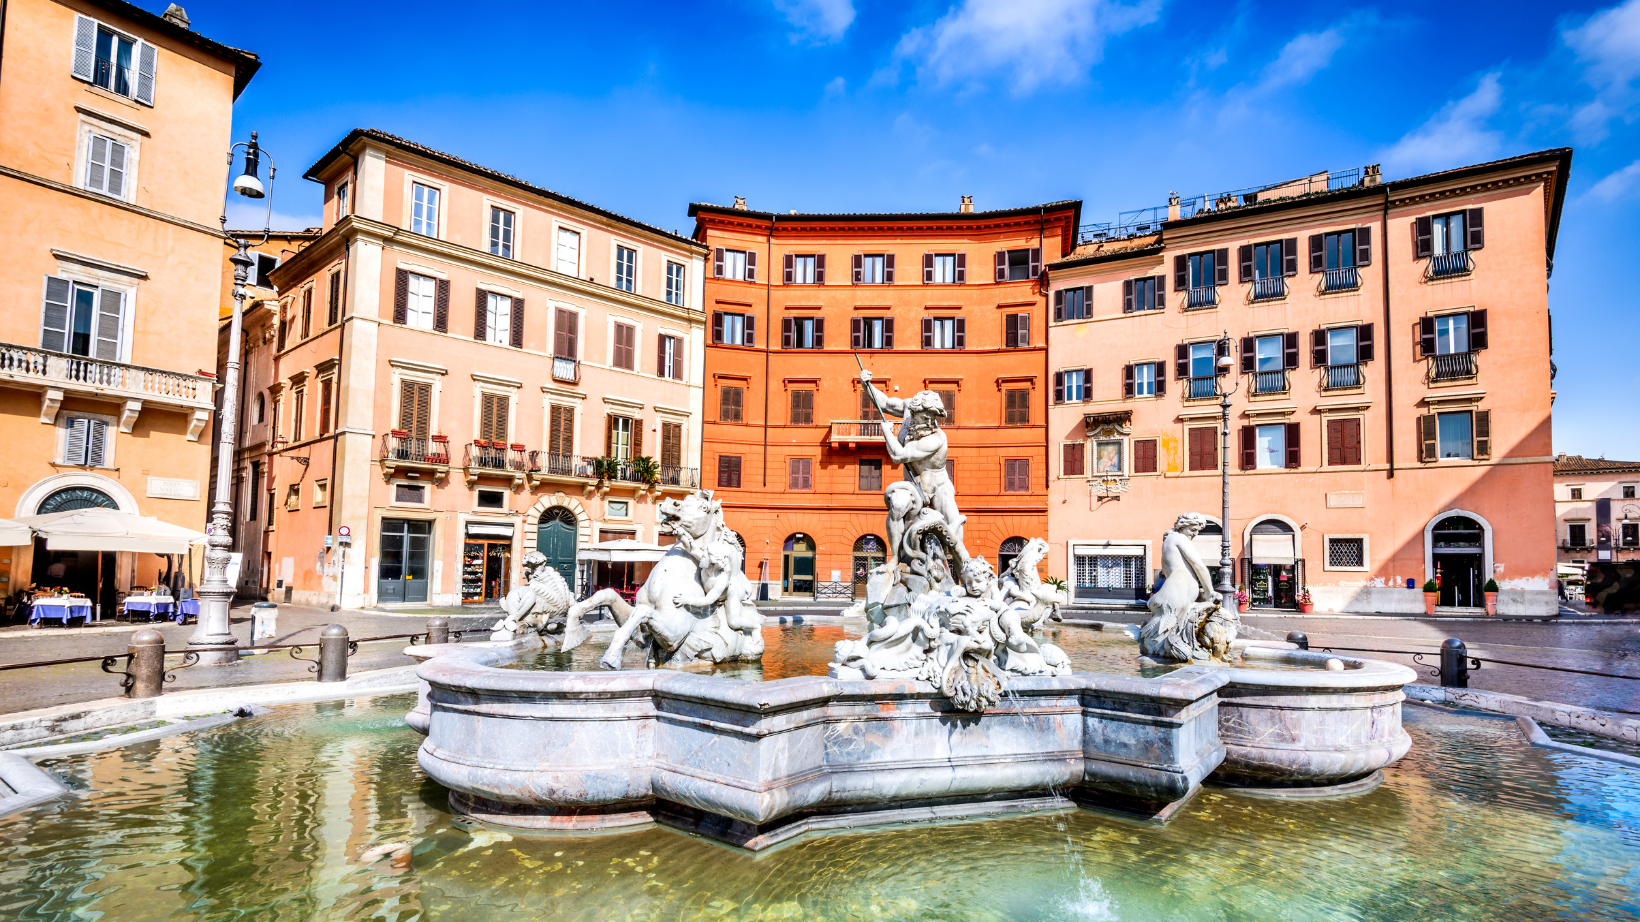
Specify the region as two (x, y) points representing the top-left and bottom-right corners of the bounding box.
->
(0, 643), (1640, 922)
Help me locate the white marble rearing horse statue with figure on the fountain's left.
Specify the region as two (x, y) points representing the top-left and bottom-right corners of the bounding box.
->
(559, 491), (763, 669)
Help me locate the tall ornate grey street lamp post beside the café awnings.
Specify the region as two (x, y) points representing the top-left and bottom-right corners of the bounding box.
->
(189, 131), (274, 666)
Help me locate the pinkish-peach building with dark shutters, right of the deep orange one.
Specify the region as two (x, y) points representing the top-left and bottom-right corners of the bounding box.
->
(1048, 149), (1571, 614)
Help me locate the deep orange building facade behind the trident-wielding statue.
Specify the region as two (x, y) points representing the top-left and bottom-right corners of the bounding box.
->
(689, 199), (1081, 599)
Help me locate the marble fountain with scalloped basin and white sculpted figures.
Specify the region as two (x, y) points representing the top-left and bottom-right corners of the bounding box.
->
(407, 369), (1414, 850)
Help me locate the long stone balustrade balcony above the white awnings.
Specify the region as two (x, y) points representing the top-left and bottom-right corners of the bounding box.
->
(0, 343), (216, 441)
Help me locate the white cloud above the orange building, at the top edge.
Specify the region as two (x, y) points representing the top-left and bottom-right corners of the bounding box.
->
(877, 0), (1161, 94)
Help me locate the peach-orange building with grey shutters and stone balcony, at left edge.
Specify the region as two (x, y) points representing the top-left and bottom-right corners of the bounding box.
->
(0, 0), (259, 617)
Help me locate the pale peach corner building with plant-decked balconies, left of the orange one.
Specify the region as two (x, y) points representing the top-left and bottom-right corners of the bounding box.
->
(262, 130), (705, 607)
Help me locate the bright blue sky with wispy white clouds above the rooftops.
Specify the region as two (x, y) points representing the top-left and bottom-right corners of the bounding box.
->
(201, 0), (1640, 458)
